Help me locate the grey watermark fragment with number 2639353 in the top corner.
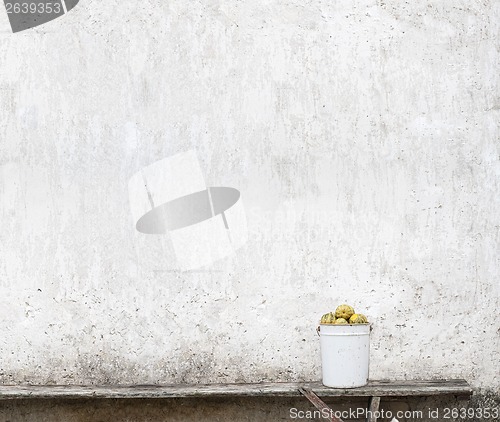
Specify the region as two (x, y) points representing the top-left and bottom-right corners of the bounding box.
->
(4, 0), (80, 32)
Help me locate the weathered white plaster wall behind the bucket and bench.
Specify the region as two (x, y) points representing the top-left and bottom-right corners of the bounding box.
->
(0, 0), (500, 392)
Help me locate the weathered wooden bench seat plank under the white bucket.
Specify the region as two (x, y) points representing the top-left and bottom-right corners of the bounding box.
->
(0, 380), (472, 400)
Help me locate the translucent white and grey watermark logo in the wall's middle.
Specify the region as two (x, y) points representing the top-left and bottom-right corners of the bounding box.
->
(128, 151), (248, 270)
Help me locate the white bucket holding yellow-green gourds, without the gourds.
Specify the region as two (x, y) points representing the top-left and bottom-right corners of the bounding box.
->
(318, 324), (370, 388)
